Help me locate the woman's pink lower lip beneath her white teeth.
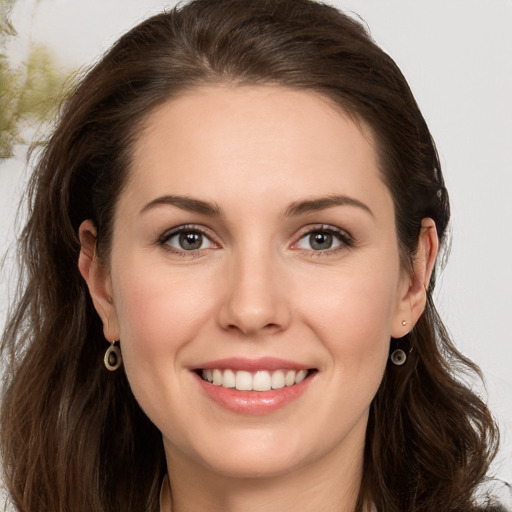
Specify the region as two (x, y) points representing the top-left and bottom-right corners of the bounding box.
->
(194, 374), (316, 415)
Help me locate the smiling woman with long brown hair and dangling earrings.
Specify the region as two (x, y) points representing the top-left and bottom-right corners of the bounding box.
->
(1, 0), (504, 512)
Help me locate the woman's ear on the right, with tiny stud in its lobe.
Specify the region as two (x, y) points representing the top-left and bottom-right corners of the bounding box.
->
(391, 218), (439, 338)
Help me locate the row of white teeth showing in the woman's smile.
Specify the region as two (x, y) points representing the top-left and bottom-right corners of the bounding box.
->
(202, 368), (308, 391)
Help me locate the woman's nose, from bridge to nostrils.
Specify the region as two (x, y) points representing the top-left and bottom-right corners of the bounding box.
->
(218, 251), (291, 336)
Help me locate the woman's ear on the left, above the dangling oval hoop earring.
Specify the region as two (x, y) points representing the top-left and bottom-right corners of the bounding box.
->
(78, 220), (119, 341)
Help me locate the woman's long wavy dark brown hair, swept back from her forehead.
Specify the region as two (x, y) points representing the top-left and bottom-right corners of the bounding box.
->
(0, 0), (497, 512)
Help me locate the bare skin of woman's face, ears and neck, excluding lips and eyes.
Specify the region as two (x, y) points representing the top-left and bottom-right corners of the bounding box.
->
(79, 86), (437, 512)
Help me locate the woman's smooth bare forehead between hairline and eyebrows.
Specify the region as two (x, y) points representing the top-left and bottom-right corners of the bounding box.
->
(122, 86), (387, 216)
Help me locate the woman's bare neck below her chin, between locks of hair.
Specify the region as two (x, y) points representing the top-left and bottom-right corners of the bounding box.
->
(162, 438), (363, 512)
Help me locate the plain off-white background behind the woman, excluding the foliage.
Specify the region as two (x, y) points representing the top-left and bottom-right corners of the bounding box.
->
(0, 0), (512, 481)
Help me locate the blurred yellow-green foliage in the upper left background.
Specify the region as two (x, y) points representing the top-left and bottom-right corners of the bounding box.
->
(0, 0), (69, 162)
